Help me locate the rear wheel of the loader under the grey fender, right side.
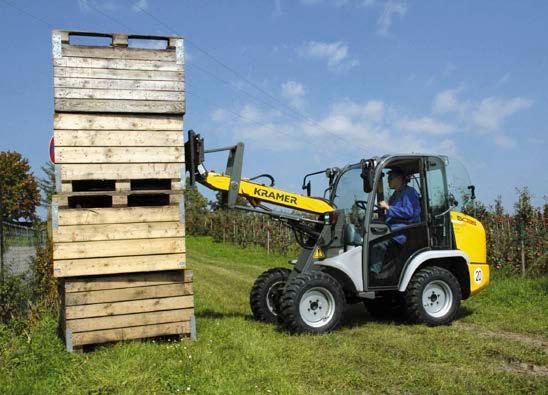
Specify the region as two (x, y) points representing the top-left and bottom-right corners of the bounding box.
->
(405, 266), (462, 326)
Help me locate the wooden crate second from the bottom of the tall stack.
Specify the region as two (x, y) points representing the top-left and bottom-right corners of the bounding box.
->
(52, 204), (186, 277)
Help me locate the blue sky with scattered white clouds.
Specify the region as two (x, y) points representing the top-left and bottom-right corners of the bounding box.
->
(0, 0), (548, 210)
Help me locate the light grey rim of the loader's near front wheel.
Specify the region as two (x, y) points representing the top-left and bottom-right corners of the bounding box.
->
(299, 287), (335, 328)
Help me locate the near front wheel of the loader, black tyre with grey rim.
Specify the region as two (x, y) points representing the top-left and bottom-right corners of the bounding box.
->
(280, 270), (345, 333)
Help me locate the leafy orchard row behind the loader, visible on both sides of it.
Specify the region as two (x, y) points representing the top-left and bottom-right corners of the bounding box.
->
(186, 208), (548, 275)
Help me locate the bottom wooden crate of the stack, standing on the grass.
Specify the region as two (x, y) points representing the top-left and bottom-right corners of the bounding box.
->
(60, 270), (196, 351)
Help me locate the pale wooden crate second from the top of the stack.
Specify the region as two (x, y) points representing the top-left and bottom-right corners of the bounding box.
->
(53, 113), (185, 185)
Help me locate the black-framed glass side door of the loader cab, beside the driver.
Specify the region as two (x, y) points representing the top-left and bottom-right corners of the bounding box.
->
(363, 157), (428, 290)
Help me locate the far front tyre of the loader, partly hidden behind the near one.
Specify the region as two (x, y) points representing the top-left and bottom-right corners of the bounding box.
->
(249, 268), (291, 322)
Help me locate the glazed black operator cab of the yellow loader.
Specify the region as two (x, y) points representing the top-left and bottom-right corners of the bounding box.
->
(331, 155), (453, 291)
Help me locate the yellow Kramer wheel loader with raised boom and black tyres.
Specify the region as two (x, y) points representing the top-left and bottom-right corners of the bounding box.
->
(185, 131), (489, 333)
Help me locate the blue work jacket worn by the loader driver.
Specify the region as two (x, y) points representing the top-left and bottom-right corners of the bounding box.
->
(385, 185), (421, 244)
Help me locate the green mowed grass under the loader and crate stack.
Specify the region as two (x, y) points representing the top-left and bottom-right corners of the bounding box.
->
(0, 238), (548, 394)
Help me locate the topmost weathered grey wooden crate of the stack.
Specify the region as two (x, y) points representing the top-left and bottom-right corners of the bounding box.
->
(52, 30), (185, 115)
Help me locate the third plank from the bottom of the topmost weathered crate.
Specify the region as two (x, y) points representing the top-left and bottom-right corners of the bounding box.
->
(53, 77), (184, 92)
